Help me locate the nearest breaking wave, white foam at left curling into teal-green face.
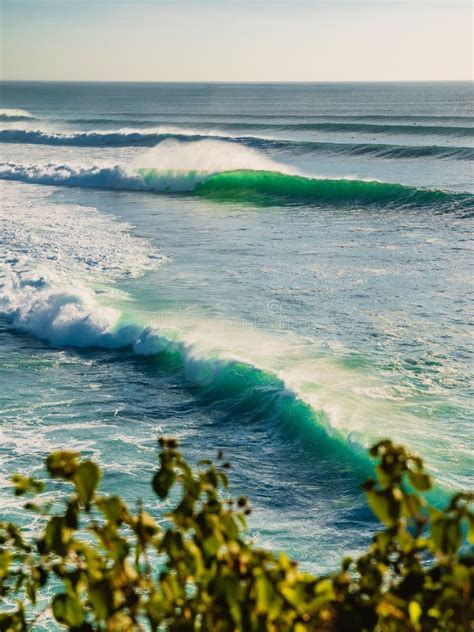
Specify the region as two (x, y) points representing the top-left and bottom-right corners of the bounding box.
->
(0, 262), (371, 474)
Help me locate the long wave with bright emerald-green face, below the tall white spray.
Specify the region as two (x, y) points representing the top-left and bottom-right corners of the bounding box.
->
(0, 163), (474, 210)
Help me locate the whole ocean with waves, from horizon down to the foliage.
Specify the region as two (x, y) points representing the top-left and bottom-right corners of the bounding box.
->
(0, 82), (474, 572)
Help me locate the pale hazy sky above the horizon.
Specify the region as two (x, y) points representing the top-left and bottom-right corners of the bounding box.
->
(0, 0), (473, 81)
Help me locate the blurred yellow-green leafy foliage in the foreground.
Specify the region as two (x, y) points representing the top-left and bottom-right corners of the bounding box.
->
(0, 439), (474, 632)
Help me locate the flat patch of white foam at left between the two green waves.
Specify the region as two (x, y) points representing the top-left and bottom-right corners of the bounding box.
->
(0, 182), (165, 281)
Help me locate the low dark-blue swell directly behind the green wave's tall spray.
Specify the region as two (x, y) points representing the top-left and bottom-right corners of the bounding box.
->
(0, 129), (474, 160)
